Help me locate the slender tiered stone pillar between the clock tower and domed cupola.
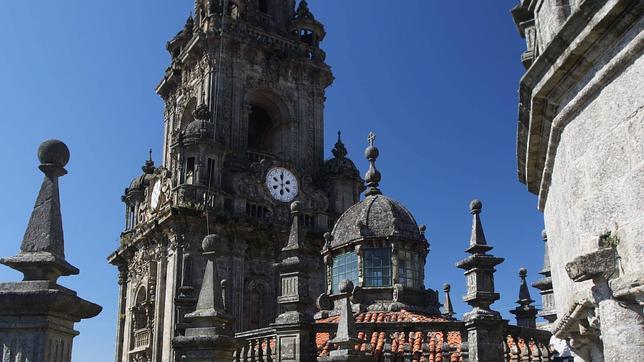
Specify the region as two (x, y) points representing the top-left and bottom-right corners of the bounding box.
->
(273, 201), (315, 361)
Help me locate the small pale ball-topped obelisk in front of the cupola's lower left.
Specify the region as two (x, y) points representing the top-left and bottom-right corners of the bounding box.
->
(330, 279), (360, 353)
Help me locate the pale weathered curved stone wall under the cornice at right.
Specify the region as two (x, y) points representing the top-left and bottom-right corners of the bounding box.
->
(544, 37), (644, 316)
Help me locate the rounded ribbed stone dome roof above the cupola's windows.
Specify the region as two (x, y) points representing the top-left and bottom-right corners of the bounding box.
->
(330, 194), (425, 249)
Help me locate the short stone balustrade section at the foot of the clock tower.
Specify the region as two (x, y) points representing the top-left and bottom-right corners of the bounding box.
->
(233, 327), (278, 362)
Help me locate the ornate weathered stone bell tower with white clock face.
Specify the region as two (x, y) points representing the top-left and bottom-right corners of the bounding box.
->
(109, 0), (363, 361)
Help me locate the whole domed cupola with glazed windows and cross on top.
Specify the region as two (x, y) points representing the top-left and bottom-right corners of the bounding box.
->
(322, 133), (439, 313)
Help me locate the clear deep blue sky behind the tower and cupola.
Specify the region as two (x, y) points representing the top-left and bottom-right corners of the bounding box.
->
(0, 0), (543, 362)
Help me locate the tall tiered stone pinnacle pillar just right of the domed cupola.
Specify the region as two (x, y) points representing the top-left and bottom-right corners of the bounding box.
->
(456, 200), (506, 361)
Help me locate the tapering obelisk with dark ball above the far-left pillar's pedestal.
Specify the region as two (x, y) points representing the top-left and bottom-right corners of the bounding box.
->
(0, 140), (78, 283)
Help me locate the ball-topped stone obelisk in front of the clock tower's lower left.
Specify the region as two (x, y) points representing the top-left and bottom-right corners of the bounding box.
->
(172, 235), (235, 362)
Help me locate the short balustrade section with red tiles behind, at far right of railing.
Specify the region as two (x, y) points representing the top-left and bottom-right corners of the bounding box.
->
(503, 325), (553, 362)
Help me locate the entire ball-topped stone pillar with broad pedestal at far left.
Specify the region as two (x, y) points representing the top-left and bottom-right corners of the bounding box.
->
(0, 140), (102, 362)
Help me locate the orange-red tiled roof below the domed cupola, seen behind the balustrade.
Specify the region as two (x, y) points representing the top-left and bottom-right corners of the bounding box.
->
(315, 310), (462, 362)
